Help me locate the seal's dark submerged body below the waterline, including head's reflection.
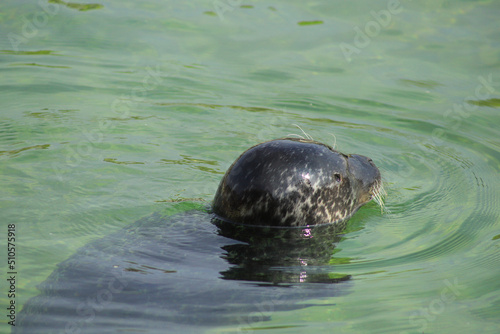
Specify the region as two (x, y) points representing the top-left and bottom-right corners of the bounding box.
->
(13, 211), (350, 334)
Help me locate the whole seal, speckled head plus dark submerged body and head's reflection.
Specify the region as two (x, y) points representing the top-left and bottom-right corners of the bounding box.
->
(13, 139), (380, 333)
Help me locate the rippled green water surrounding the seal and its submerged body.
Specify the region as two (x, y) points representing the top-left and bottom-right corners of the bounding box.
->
(0, 0), (500, 333)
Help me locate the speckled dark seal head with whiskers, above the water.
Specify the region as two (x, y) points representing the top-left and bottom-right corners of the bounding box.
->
(213, 138), (383, 227)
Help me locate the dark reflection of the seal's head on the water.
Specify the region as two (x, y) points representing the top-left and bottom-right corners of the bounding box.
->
(212, 219), (350, 284)
